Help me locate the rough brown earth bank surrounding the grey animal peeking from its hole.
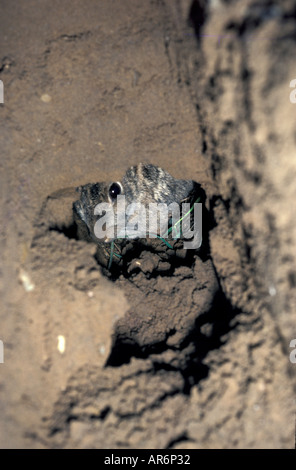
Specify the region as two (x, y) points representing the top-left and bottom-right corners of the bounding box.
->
(0, 0), (296, 449)
